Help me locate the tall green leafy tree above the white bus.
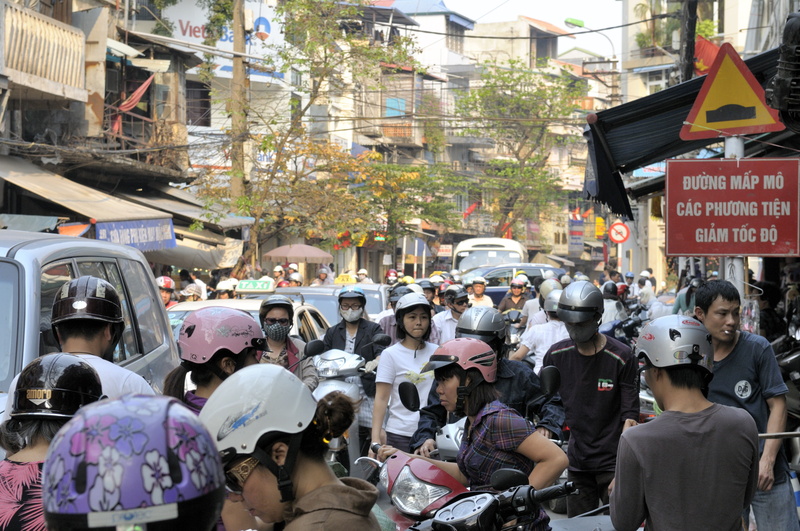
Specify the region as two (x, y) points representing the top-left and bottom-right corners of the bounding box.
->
(456, 60), (586, 236)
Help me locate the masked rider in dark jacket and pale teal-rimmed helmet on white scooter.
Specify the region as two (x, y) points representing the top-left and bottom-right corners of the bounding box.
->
(322, 286), (383, 455)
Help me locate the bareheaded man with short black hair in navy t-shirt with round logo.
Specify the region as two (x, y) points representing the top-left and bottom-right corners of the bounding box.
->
(695, 280), (800, 530)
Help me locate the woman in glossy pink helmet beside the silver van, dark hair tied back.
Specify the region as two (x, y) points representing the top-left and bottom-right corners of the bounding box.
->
(164, 306), (264, 531)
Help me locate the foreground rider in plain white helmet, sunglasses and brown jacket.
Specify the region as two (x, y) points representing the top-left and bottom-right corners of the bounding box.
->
(200, 364), (380, 531)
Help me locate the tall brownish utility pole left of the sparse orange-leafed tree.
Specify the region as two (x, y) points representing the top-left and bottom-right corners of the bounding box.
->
(229, 0), (247, 204)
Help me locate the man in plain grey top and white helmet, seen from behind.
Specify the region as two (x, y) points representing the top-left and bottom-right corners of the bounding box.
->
(611, 315), (756, 531)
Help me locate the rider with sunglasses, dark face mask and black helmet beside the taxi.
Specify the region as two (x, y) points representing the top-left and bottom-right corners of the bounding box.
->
(258, 295), (319, 391)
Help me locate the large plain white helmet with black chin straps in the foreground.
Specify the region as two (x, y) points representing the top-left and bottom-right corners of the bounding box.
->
(200, 363), (317, 501)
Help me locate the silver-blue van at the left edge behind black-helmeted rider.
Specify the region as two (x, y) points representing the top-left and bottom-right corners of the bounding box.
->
(0, 230), (180, 407)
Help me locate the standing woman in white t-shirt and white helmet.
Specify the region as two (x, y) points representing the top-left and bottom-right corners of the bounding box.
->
(372, 293), (437, 451)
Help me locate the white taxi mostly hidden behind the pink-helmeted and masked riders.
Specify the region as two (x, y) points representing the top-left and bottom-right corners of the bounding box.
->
(167, 299), (330, 343)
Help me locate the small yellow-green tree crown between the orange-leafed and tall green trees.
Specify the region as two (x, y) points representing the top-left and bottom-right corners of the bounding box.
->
(355, 162), (463, 262)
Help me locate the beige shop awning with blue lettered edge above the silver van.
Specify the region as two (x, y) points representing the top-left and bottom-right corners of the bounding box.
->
(0, 157), (175, 251)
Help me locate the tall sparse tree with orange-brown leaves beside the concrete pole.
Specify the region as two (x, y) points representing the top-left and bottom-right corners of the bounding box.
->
(193, 0), (413, 261)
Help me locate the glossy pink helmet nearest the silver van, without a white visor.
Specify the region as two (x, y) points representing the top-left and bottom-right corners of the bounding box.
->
(178, 308), (264, 364)
